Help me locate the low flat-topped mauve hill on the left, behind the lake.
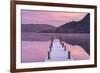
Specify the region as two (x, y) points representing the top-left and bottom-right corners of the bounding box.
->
(21, 24), (56, 33)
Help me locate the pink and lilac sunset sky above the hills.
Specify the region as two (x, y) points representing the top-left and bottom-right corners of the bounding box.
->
(21, 10), (86, 27)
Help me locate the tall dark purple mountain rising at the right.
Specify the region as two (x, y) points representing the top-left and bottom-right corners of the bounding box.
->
(55, 13), (90, 33)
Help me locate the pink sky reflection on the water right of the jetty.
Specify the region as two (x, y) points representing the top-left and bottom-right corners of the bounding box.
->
(65, 43), (89, 60)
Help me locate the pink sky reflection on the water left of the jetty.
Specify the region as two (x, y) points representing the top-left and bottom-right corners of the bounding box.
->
(21, 41), (50, 63)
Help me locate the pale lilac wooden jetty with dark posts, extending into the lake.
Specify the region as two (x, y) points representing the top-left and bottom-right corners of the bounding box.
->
(46, 38), (72, 61)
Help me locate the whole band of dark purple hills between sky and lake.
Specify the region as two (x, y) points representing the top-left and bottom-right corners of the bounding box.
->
(21, 13), (90, 33)
